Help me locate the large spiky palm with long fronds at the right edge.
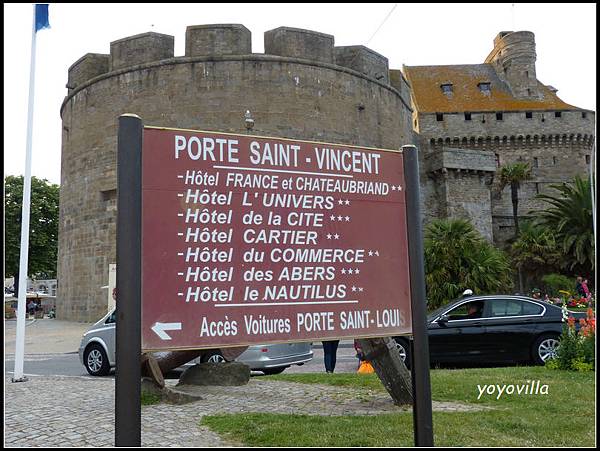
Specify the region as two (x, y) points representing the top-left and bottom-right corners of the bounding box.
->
(536, 176), (595, 274)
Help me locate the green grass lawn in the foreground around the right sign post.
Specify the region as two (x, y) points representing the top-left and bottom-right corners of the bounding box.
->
(202, 367), (595, 447)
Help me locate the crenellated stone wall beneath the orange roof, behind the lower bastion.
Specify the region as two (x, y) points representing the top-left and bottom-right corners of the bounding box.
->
(418, 110), (595, 245)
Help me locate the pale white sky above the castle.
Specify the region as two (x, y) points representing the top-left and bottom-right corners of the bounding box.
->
(4, 3), (596, 184)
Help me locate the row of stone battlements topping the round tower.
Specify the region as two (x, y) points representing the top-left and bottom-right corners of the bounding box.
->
(67, 24), (400, 94)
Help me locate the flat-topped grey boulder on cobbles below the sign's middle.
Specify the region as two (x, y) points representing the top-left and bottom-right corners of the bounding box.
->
(177, 362), (250, 386)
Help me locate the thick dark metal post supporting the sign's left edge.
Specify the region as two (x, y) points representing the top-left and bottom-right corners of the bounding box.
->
(115, 114), (142, 446)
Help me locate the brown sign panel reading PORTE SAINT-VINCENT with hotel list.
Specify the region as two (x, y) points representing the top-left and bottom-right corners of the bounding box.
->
(142, 127), (412, 351)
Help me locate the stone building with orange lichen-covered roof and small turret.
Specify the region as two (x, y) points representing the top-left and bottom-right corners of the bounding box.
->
(404, 31), (595, 245)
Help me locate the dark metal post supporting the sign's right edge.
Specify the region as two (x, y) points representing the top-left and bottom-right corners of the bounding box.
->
(402, 146), (433, 446)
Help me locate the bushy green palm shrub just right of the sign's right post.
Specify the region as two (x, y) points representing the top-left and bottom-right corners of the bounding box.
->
(424, 219), (512, 309)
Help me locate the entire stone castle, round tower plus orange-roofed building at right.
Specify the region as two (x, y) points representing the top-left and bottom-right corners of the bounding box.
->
(57, 24), (594, 321)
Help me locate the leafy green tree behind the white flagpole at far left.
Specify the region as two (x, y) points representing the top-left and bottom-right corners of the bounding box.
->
(4, 175), (59, 285)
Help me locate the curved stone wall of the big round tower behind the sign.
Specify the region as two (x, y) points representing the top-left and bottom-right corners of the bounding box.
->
(57, 25), (413, 321)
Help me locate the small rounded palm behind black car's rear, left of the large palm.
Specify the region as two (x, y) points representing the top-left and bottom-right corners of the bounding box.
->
(510, 221), (562, 285)
